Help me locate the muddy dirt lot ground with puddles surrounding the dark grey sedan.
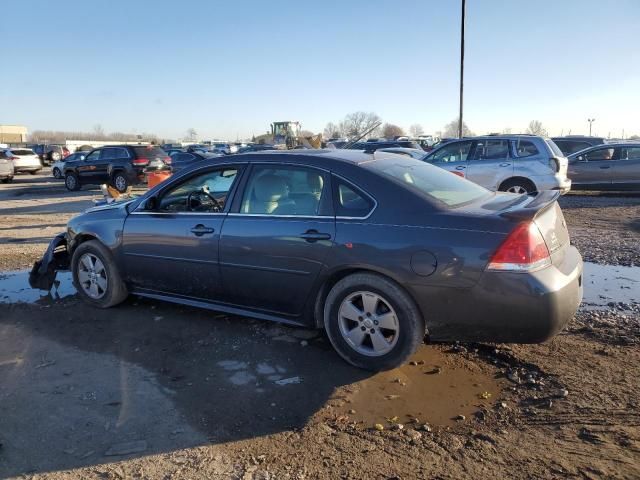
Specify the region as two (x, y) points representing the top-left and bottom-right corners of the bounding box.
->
(0, 171), (640, 479)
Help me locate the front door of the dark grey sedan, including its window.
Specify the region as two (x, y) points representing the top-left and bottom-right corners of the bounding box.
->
(122, 165), (241, 301)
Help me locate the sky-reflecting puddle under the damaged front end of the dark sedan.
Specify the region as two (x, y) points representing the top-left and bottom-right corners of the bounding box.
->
(0, 270), (76, 304)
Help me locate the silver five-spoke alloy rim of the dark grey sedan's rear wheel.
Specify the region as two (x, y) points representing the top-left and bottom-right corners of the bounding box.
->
(338, 291), (400, 357)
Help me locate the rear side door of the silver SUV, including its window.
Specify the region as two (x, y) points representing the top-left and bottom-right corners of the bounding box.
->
(465, 138), (514, 191)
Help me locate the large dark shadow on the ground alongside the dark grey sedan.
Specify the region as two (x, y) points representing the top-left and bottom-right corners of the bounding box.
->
(0, 297), (371, 478)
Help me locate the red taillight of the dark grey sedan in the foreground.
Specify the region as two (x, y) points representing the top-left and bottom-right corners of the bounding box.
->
(487, 222), (551, 272)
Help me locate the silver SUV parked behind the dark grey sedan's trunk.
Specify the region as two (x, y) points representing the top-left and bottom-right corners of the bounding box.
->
(424, 135), (571, 193)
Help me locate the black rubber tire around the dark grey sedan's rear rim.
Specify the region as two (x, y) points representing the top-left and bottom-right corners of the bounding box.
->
(324, 273), (426, 371)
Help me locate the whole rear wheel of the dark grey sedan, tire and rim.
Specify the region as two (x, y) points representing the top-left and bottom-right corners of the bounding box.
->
(324, 273), (425, 371)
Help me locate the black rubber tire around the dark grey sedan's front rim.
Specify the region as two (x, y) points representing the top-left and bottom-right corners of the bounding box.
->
(71, 240), (129, 308)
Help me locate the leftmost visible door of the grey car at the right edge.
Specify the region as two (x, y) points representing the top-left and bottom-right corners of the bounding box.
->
(567, 145), (616, 189)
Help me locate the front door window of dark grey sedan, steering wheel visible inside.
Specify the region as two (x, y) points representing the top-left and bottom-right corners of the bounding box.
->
(158, 167), (238, 213)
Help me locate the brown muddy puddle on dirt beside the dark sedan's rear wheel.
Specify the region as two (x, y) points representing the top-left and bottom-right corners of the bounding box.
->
(338, 345), (501, 429)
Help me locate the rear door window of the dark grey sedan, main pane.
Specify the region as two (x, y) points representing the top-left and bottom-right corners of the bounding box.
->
(240, 165), (326, 216)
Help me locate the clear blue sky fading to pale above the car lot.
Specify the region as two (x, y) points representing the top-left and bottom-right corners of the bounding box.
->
(0, 0), (640, 140)
